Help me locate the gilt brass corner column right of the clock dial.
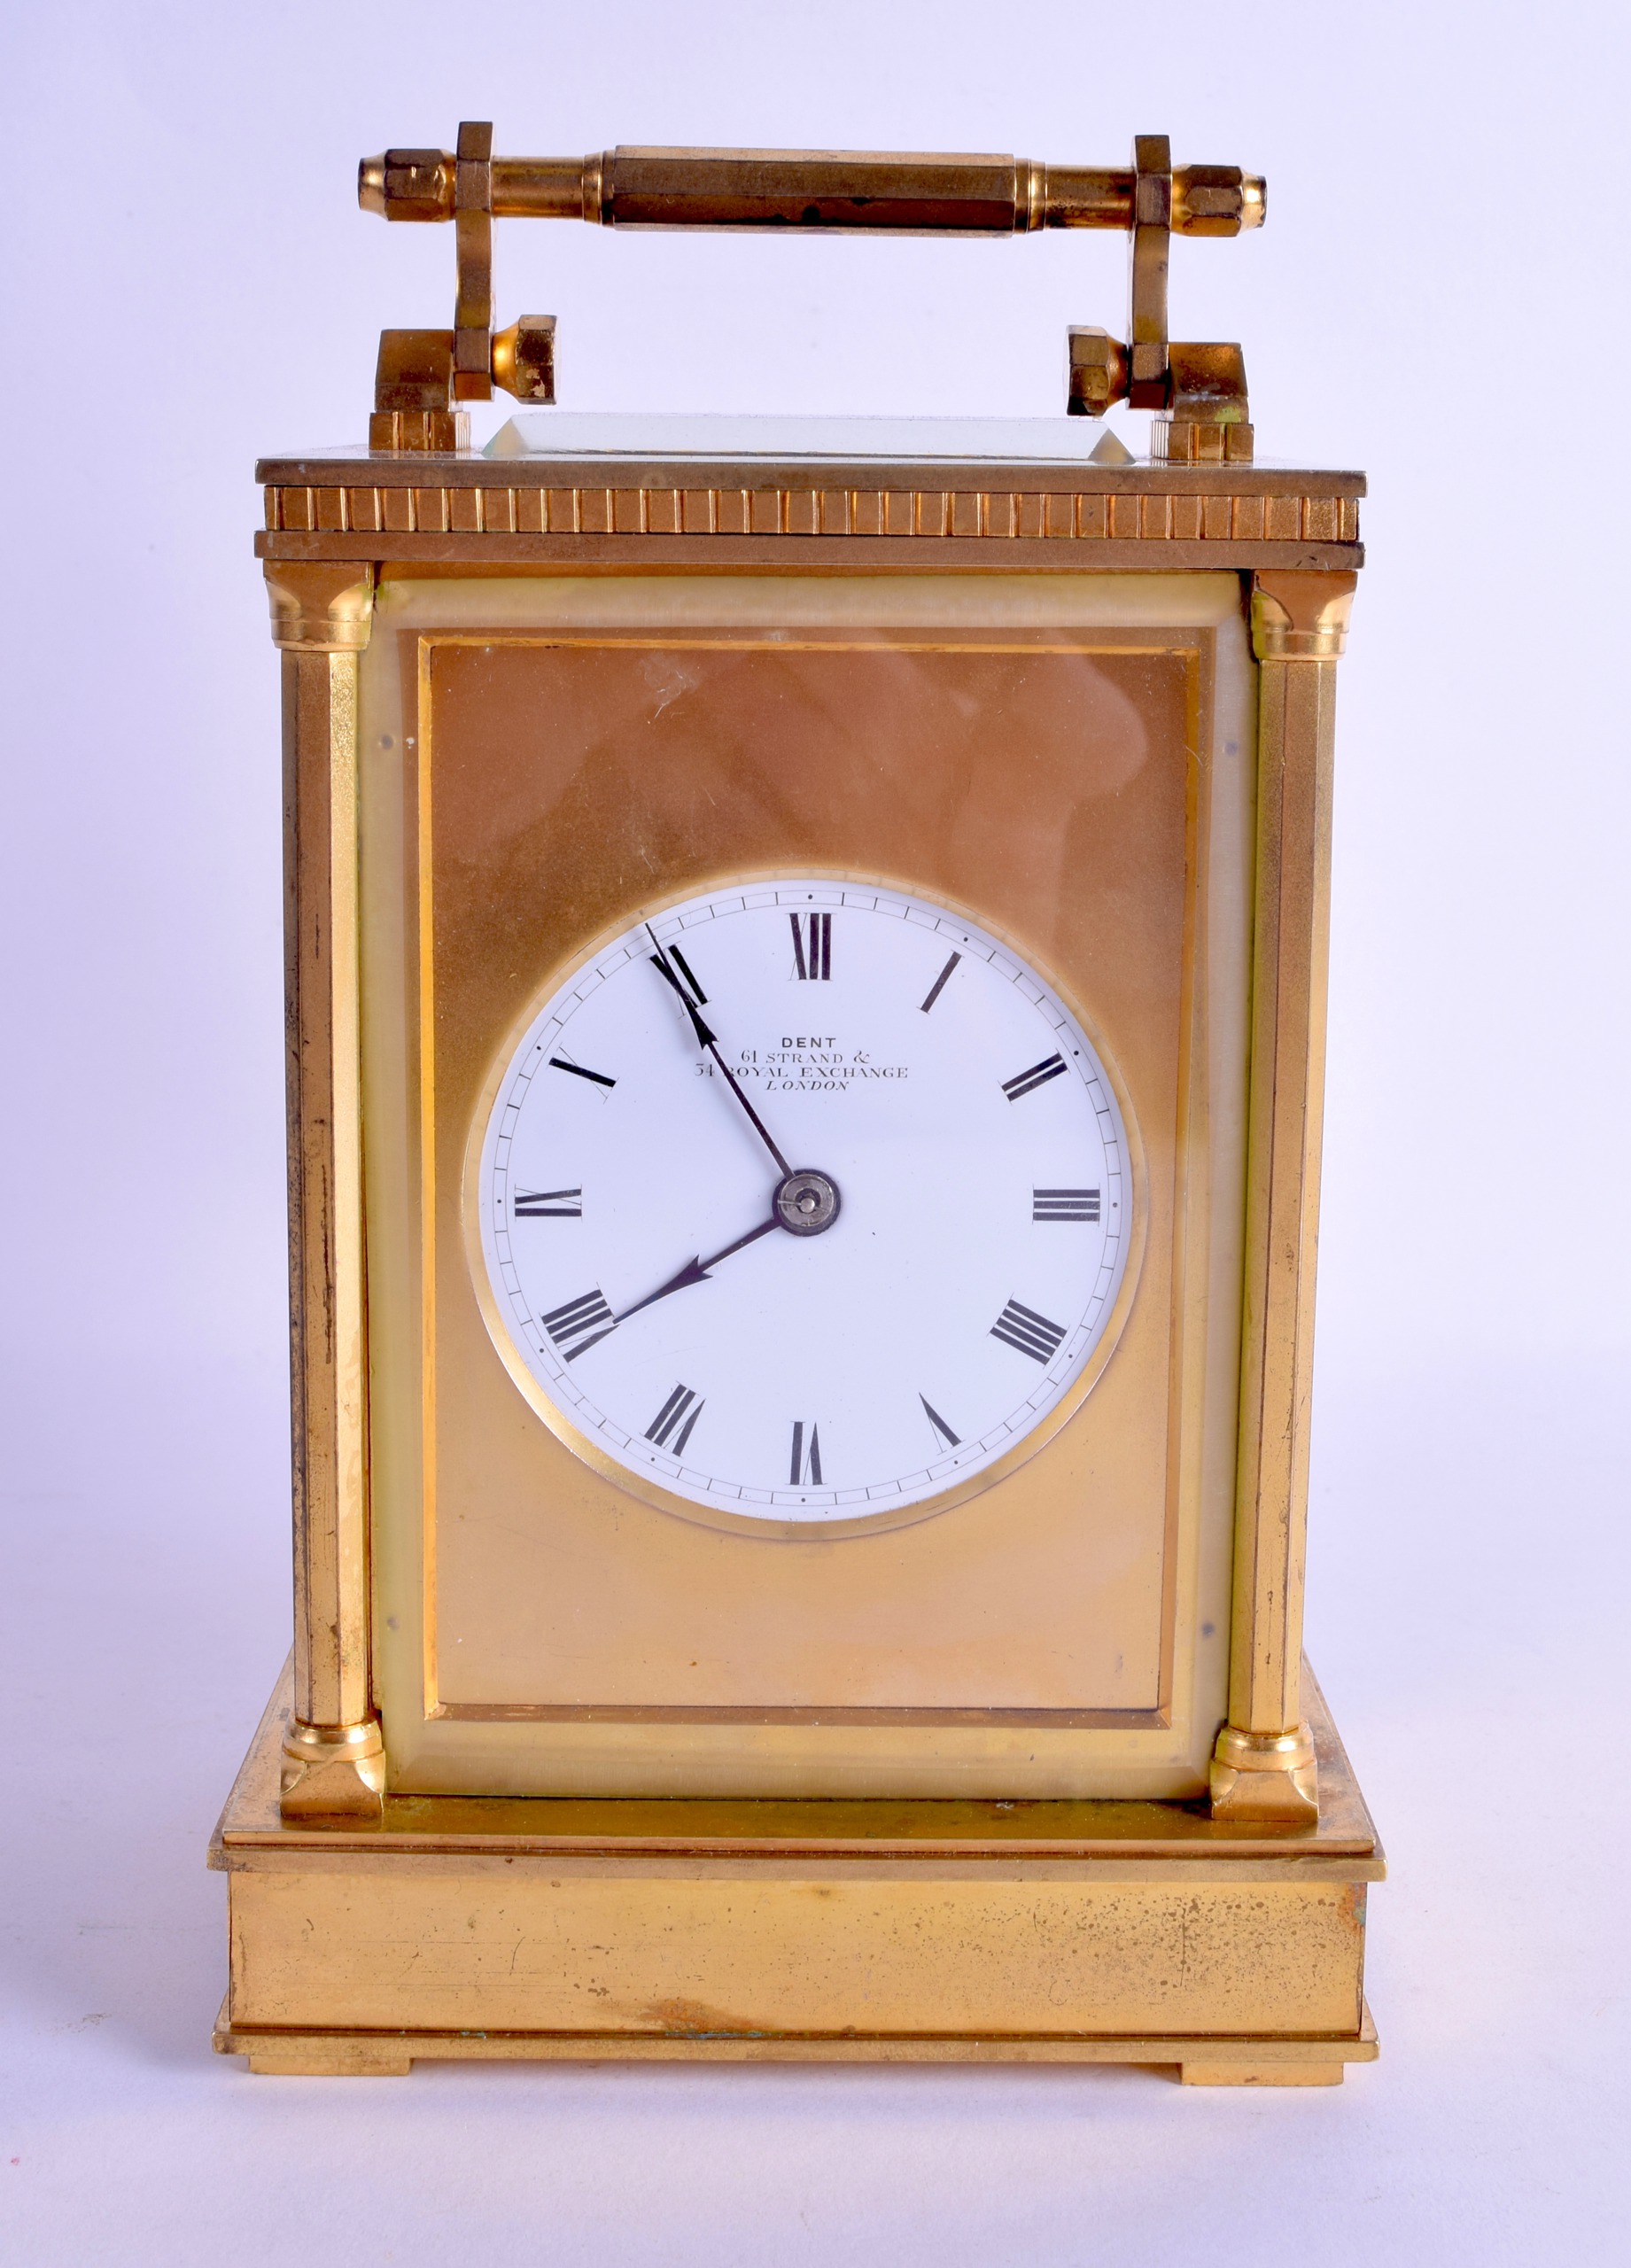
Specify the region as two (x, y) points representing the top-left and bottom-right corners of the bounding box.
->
(1211, 571), (1356, 1826)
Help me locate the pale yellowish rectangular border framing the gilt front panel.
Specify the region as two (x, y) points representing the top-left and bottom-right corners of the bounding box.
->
(346, 576), (1252, 1798)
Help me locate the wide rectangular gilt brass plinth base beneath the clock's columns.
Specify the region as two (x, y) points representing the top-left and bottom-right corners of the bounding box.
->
(209, 1678), (1384, 2086)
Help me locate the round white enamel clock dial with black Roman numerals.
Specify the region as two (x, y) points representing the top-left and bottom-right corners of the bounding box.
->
(472, 880), (1134, 1526)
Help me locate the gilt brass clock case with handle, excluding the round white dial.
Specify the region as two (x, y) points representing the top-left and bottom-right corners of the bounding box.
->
(214, 127), (1381, 2085)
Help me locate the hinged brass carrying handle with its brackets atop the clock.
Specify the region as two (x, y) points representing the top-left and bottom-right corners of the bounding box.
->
(356, 125), (1266, 462)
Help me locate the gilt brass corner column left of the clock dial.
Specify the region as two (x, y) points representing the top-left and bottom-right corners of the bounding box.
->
(266, 560), (385, 1821)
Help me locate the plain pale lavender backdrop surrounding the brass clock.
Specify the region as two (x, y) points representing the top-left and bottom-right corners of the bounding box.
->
(0, 0), (1631, 2268)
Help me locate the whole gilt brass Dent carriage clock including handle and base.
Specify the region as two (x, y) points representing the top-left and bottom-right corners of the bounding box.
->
(214, 125), (1381, 2085)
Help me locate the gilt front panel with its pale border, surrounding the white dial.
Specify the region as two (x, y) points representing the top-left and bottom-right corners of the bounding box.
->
(353, 579), (1250, 1794)
